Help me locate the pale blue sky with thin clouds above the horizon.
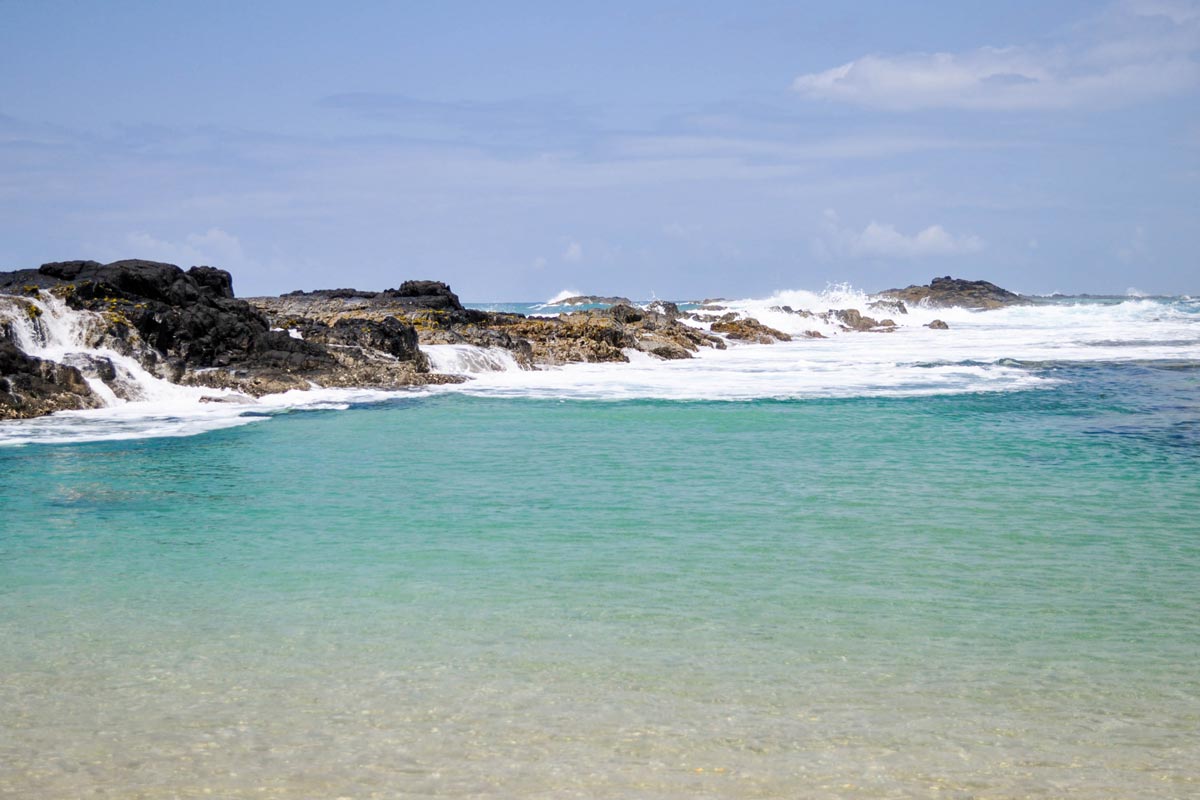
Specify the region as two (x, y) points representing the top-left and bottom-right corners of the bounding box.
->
(0, 0), (1200, 302)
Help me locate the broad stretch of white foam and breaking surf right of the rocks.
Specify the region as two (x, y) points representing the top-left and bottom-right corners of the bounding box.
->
(424, 291), (1200, 401)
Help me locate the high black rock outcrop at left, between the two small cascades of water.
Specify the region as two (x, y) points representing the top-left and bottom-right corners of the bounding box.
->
(0, 260), (446, 413)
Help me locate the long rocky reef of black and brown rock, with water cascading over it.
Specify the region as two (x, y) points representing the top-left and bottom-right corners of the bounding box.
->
(0, 260), (1024, 419)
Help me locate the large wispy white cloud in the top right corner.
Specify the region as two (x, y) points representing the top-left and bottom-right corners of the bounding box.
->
(792, 0), (1200, 110)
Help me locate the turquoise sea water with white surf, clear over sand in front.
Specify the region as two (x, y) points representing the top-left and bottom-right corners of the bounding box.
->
(0, 293), (1200, 799)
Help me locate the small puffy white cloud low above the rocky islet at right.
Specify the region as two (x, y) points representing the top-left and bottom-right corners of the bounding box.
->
(812, 211), (984, 259)
